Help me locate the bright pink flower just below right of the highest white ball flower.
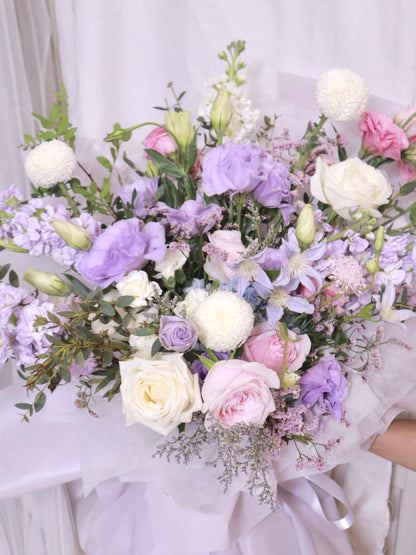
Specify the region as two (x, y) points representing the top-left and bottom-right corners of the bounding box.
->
(358, 112), (409, 160)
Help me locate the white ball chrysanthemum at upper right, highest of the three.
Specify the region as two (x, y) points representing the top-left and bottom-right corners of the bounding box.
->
(315, 68), (369, 121)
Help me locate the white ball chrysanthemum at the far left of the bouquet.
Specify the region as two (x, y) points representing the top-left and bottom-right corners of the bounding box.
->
(25, 139), (77, 187)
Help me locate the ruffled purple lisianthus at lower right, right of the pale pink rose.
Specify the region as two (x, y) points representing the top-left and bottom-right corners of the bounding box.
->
(299, 356), (348, 427)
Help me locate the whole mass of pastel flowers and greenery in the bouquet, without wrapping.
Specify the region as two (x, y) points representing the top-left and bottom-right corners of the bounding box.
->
(0, 41), (416, 506)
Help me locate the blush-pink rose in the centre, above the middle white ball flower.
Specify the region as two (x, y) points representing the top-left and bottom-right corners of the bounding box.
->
(204, 230), (246, 283)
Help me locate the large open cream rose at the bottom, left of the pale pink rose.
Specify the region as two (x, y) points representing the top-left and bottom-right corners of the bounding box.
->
(120, 353), (202, 435)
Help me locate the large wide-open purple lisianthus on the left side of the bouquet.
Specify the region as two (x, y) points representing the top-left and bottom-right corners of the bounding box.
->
(78, 218), (166, 287)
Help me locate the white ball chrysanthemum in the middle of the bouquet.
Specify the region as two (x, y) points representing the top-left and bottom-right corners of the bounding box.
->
(192, 291), (254, 352)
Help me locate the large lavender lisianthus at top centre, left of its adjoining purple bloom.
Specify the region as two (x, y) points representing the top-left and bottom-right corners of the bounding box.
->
(202, 142), (262, 196)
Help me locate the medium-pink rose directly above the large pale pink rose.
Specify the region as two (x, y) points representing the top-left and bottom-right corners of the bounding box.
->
(243, 322), (311, 376)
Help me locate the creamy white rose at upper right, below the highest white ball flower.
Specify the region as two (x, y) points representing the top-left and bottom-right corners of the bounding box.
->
(311, 158), (392, 220)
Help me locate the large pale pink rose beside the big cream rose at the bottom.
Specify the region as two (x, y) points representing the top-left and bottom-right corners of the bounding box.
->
(202, 359), (280, 428)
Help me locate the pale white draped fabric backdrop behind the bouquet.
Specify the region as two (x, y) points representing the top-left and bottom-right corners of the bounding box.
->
(0, 0), (416, 555)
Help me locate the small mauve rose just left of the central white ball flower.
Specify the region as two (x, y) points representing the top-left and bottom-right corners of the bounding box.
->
(159, 316), (198, 353)
